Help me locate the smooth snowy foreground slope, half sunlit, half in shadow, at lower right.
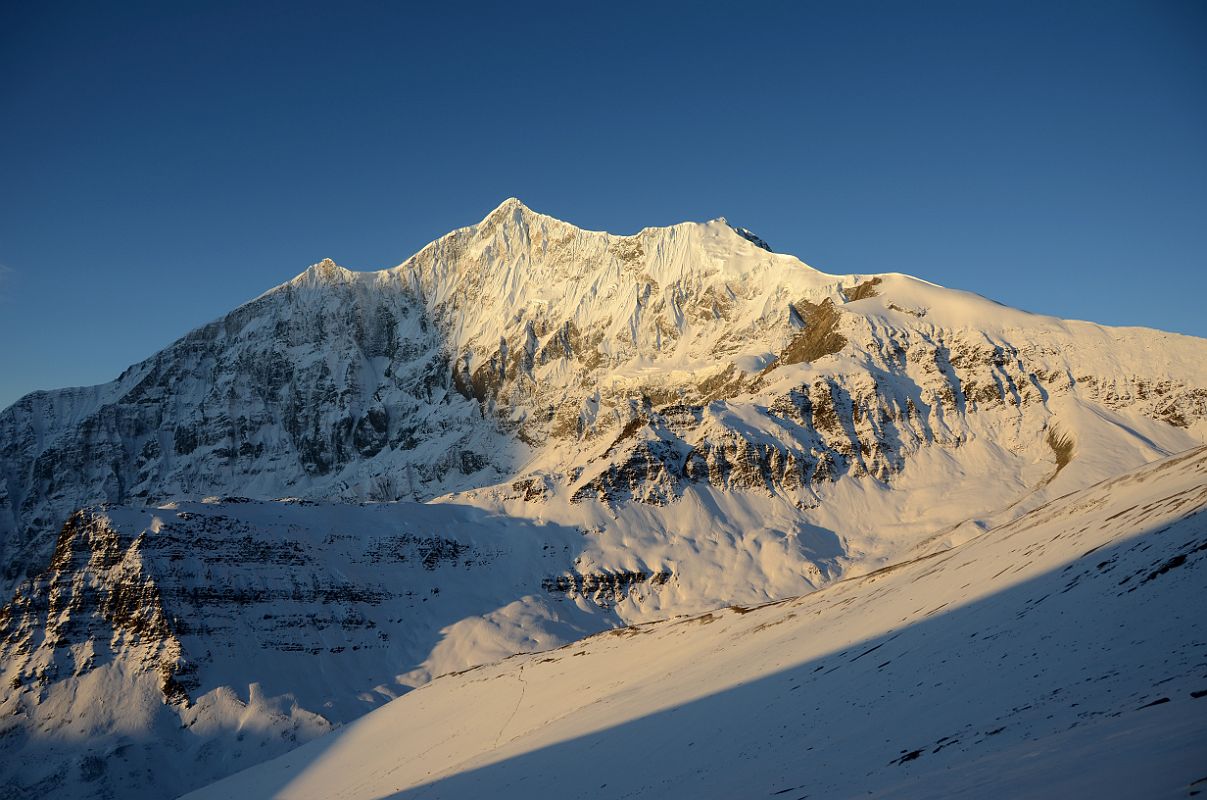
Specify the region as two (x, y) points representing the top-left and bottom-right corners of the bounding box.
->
(188, 448), (1207, 800)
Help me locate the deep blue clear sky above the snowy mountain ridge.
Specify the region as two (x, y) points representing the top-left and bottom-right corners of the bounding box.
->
(0, 0), (1207, 407)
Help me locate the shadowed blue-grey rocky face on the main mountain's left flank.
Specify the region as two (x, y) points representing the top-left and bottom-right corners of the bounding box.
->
(0, 262), (519, 591)
